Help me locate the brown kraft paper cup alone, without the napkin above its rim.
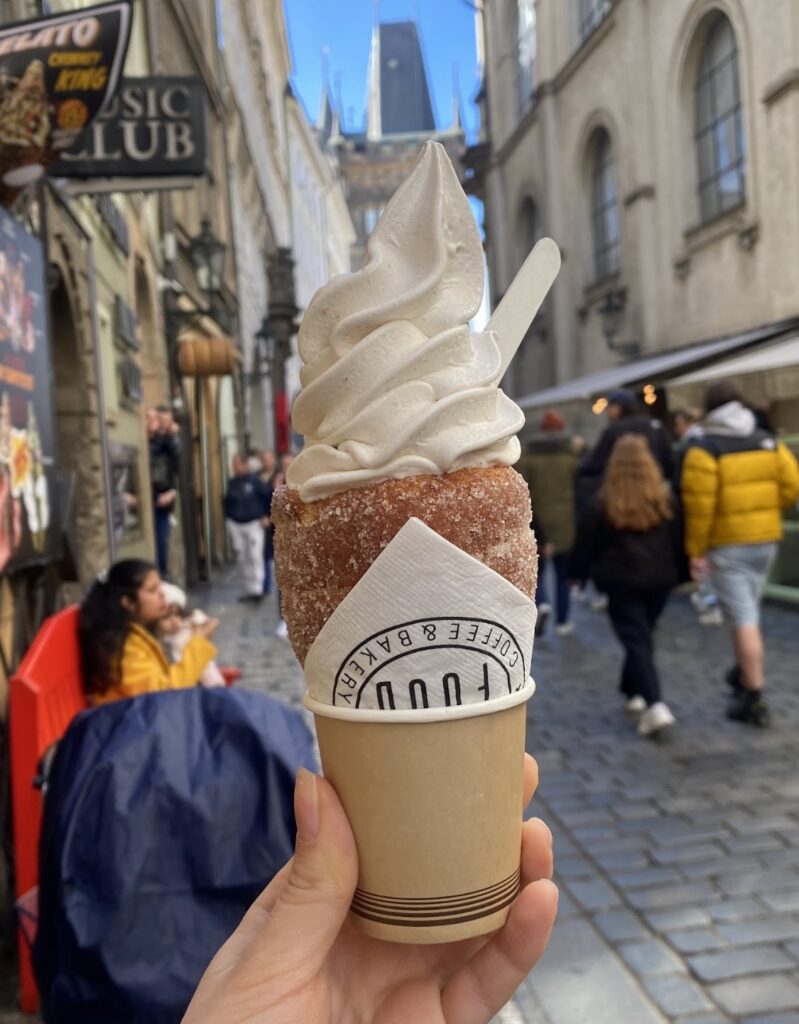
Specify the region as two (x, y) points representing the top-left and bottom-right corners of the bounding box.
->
(306, 684), (534, 943)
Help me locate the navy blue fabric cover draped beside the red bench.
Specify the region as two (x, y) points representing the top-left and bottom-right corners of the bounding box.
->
(34, 687), (314, 1024)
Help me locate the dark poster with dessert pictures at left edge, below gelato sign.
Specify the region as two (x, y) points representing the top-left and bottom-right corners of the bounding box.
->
(0, 203), (58, 572)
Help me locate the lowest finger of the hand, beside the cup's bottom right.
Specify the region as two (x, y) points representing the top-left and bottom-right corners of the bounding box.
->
(441, 881), (557, 1024)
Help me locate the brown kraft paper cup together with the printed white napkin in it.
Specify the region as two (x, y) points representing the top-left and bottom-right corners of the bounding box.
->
(303, 518), (536, 943)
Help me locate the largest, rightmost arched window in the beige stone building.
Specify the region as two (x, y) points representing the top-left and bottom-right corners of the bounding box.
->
(696, 14), (746, 221)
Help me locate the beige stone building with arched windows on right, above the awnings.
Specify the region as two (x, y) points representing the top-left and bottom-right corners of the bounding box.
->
(466, 0), (799, 429)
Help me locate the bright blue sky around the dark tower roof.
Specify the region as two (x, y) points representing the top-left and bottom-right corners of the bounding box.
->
(285, 0), (477, 140)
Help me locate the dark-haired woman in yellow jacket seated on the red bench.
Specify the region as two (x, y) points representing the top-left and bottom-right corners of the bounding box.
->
(78, 559), (219, 706)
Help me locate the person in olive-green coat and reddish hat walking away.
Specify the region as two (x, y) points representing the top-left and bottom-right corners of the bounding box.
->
(518, 409), (578, 636)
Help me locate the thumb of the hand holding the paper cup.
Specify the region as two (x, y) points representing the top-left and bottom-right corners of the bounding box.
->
(268, 768), (358, 976)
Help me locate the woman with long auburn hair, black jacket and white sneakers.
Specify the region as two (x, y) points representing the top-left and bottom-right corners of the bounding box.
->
(570, 434), (681, 736)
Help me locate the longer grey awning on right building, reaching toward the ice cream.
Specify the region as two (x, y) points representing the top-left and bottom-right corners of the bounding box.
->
(515, 317), (799, 412)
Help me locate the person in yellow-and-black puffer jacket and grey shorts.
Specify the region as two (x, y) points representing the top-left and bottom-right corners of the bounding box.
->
(680, 381), (799, 725)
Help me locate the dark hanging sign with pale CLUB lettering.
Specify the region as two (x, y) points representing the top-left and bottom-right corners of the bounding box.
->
(50, 76), (206, 179)
